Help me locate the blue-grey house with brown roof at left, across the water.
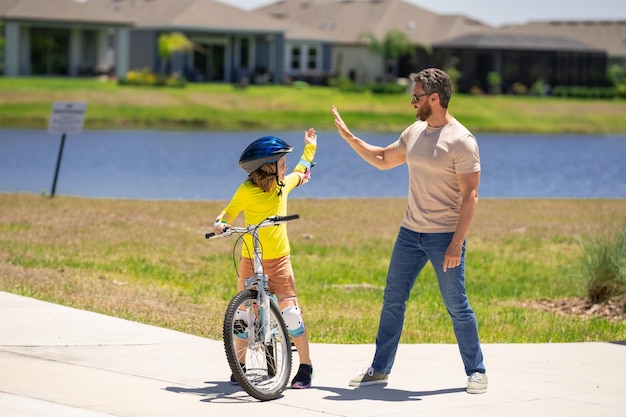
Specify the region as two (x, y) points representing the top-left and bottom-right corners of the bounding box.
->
(0, 0), (284, 82)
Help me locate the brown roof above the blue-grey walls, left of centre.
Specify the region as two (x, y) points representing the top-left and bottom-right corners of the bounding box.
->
(121, 0), (284, 33)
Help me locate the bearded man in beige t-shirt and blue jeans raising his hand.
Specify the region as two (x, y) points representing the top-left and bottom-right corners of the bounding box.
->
(331, 68), (487, 394)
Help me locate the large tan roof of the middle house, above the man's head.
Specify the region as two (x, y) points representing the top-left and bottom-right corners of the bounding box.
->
(255, 0), (495, 45)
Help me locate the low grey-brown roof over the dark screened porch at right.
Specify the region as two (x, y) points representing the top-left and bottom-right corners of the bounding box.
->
(433, 33), (605, 52)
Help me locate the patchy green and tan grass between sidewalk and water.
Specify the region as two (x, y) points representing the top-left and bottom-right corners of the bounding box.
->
(0, 194), (626, 343)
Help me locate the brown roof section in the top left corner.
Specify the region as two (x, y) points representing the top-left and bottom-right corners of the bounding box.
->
(0, 0), (133, 25)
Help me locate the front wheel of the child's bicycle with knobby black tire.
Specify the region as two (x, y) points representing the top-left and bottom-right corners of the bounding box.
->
(223, 289), (292, 401)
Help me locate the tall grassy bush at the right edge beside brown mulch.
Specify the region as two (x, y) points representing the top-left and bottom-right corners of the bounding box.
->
(581, 225), (626, 303)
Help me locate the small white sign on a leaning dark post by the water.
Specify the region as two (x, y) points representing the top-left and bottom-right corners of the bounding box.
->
(48, 102), (87, 198)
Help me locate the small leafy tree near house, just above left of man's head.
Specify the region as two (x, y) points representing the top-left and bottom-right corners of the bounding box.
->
(359, 29), (417, 78)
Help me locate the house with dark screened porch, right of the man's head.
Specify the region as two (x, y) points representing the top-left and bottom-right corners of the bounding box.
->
(433, 31), (607, 92)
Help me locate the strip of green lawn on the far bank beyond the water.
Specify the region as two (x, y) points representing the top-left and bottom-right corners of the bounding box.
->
(0, 77), (626, 134)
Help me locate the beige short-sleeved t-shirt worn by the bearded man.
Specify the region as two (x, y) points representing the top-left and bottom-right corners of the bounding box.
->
(394, 118), (480, 233)
